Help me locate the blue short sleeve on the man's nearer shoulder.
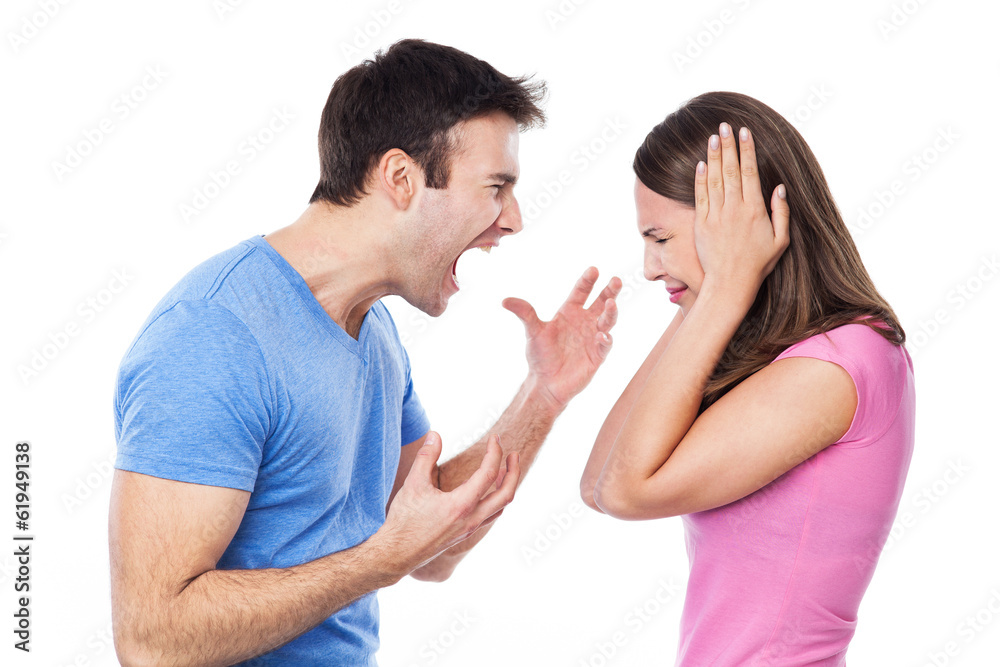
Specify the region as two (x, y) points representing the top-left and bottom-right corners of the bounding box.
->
(115, 301), (271, 491)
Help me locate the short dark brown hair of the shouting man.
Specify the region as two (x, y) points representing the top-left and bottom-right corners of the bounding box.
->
(309, 39), (545, 206)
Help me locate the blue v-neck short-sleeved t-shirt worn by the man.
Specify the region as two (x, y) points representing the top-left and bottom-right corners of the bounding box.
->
(115, 236), (429, 665)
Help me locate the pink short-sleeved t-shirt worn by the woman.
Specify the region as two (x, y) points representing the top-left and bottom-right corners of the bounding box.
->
(676, 324), (916, 667)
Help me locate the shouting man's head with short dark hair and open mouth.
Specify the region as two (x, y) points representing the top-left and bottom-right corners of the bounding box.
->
(310, 40), (545, 316)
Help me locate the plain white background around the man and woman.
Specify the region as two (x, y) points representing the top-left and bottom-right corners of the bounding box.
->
(0, 0), (1000, 667)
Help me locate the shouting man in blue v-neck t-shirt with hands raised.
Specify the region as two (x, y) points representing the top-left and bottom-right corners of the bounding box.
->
(110, 40), (621, 665)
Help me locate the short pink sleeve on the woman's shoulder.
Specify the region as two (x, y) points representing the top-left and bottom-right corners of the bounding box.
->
(772, 324), (910, 447)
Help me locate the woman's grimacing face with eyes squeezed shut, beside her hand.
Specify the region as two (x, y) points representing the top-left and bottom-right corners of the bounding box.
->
(635, 178), (705, 315)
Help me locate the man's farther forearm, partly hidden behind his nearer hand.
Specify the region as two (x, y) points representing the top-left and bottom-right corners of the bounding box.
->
(413, 377), (565, 581)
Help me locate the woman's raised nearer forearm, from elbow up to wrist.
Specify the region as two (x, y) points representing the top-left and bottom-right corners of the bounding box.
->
(594, 282), (752, 514)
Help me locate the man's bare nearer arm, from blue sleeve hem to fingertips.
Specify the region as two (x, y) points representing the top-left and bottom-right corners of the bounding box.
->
(109, 437), (520, 667)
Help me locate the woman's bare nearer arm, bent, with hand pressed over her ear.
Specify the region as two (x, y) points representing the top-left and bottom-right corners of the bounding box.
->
(594, 124), (812, 519)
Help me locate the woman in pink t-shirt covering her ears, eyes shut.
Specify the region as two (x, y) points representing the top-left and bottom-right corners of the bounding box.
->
(581, 93), (915, 667)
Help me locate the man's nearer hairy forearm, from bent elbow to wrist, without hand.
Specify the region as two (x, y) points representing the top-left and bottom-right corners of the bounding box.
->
(120, 534), (406, 667)
